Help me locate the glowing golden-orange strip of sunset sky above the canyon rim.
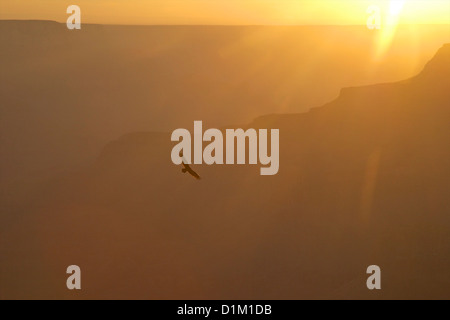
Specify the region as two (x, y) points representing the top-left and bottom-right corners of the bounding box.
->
(0, 0), (450, 24)
